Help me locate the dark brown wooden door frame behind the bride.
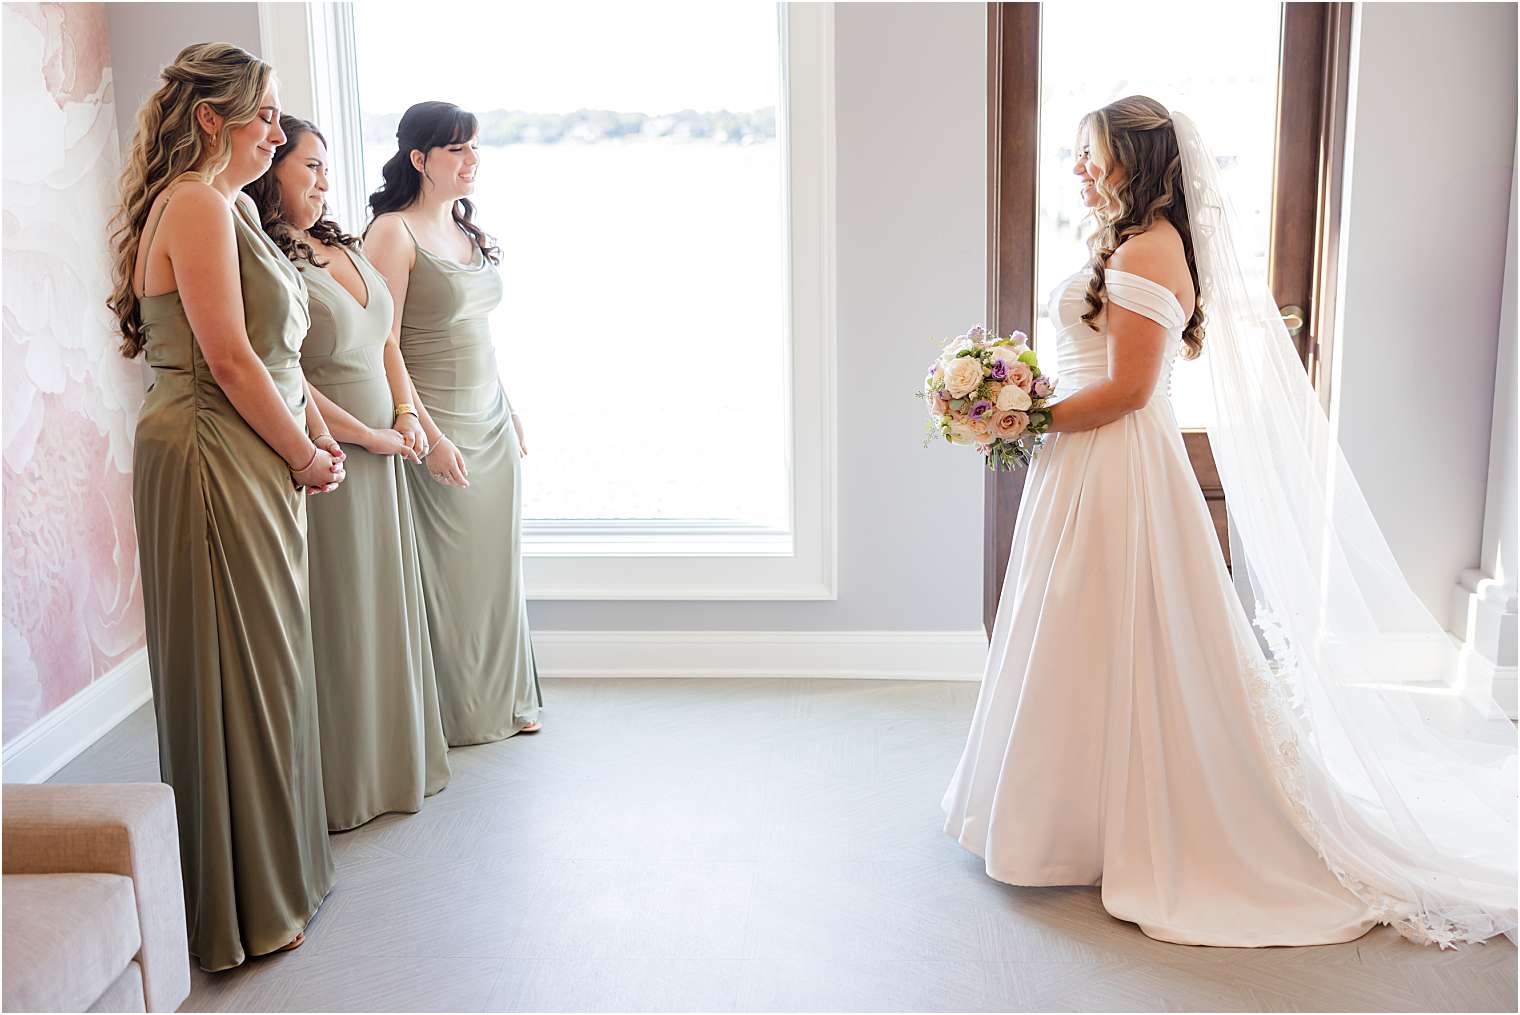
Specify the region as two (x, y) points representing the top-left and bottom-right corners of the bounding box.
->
(982, 3), (1353, 634)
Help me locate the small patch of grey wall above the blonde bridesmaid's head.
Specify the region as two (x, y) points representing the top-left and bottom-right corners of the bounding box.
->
(105, 3), (260, 152)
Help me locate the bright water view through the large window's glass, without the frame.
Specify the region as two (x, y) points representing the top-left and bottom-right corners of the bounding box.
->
(354, 3), (790, 527)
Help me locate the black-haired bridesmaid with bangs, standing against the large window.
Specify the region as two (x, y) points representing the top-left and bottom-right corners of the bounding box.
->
(365, 102), (543, 746)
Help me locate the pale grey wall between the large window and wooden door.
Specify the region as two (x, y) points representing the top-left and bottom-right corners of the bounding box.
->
(529, 3), (986, 632)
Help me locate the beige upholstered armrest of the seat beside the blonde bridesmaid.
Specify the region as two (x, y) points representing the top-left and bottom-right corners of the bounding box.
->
(0, 783), (190, 1012)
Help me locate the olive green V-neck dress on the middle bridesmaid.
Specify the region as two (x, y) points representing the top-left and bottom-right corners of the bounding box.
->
(296, 243), (448, 831)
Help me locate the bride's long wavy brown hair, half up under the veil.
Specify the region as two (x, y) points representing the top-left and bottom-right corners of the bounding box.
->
(1081, 96), (1204, 359)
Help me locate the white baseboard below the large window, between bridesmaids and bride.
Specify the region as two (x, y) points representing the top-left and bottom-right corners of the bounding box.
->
(534, 631), (986, 681)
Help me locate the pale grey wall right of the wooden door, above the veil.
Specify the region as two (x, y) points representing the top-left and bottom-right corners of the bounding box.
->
(1335, 3), (1515, 621)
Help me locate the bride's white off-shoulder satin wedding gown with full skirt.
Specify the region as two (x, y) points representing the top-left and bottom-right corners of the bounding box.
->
(942, 267), (1377, 947)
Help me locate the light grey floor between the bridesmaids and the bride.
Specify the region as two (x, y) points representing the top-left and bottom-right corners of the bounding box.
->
(55, 679), (1517, 1012)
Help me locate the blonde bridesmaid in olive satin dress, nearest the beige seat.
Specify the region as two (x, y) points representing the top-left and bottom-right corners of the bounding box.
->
(109, 43), (344, 971)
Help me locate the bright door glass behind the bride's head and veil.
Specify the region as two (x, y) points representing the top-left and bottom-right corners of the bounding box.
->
(1035, 0), (1281, 427)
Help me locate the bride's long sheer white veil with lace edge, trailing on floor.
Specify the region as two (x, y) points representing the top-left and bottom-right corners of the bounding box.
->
(1172, 112), (1517, 948)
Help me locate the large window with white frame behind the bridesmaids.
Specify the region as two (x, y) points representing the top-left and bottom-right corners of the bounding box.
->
(275, 2), (833, 599)
